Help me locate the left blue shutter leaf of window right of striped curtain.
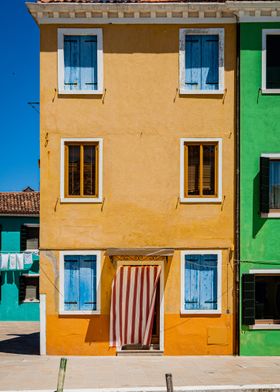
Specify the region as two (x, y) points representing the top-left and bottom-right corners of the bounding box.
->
(184, 255), (201, 310)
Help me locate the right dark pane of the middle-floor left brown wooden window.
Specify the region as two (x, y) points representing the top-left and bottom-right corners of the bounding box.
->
(84, 146), (96, 196)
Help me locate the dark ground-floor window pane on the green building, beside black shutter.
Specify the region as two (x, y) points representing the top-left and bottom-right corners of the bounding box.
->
(255, 275), (280, 320)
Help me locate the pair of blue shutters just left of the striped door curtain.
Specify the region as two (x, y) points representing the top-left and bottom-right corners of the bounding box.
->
(64, 255), (97, 311)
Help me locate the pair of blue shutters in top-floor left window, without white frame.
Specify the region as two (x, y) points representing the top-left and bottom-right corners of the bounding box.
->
(64, 35), (98, 91)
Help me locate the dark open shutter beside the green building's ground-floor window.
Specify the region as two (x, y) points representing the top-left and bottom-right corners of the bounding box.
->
(242, 274), (255, 325)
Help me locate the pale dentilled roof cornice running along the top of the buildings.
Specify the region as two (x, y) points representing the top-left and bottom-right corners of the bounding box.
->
(26, 1), (280, 25)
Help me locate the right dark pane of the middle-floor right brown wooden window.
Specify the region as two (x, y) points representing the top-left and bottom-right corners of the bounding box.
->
(203, 145), (215, 195)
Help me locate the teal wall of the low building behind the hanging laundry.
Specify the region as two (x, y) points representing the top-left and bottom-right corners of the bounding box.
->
(0, 216), (39, 321)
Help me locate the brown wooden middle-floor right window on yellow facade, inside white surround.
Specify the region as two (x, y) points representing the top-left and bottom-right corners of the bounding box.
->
(184, 143), (218, 198)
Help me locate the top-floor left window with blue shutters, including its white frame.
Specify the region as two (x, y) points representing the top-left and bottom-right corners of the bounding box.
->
(58, 29), (103, 94)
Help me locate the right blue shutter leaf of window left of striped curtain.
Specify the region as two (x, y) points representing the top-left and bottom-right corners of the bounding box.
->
(79, 256), (96, 310)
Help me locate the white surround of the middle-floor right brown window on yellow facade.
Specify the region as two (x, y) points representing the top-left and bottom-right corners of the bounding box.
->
(180, 138), (223, 204)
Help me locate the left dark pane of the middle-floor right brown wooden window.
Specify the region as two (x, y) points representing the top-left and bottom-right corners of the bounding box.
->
(188, 145), (200, 195)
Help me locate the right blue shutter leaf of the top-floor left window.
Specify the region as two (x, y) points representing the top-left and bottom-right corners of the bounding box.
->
(81, 35), (97, 90)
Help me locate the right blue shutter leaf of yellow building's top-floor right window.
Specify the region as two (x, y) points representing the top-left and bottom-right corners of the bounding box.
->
(201, 35), (219, 90)
